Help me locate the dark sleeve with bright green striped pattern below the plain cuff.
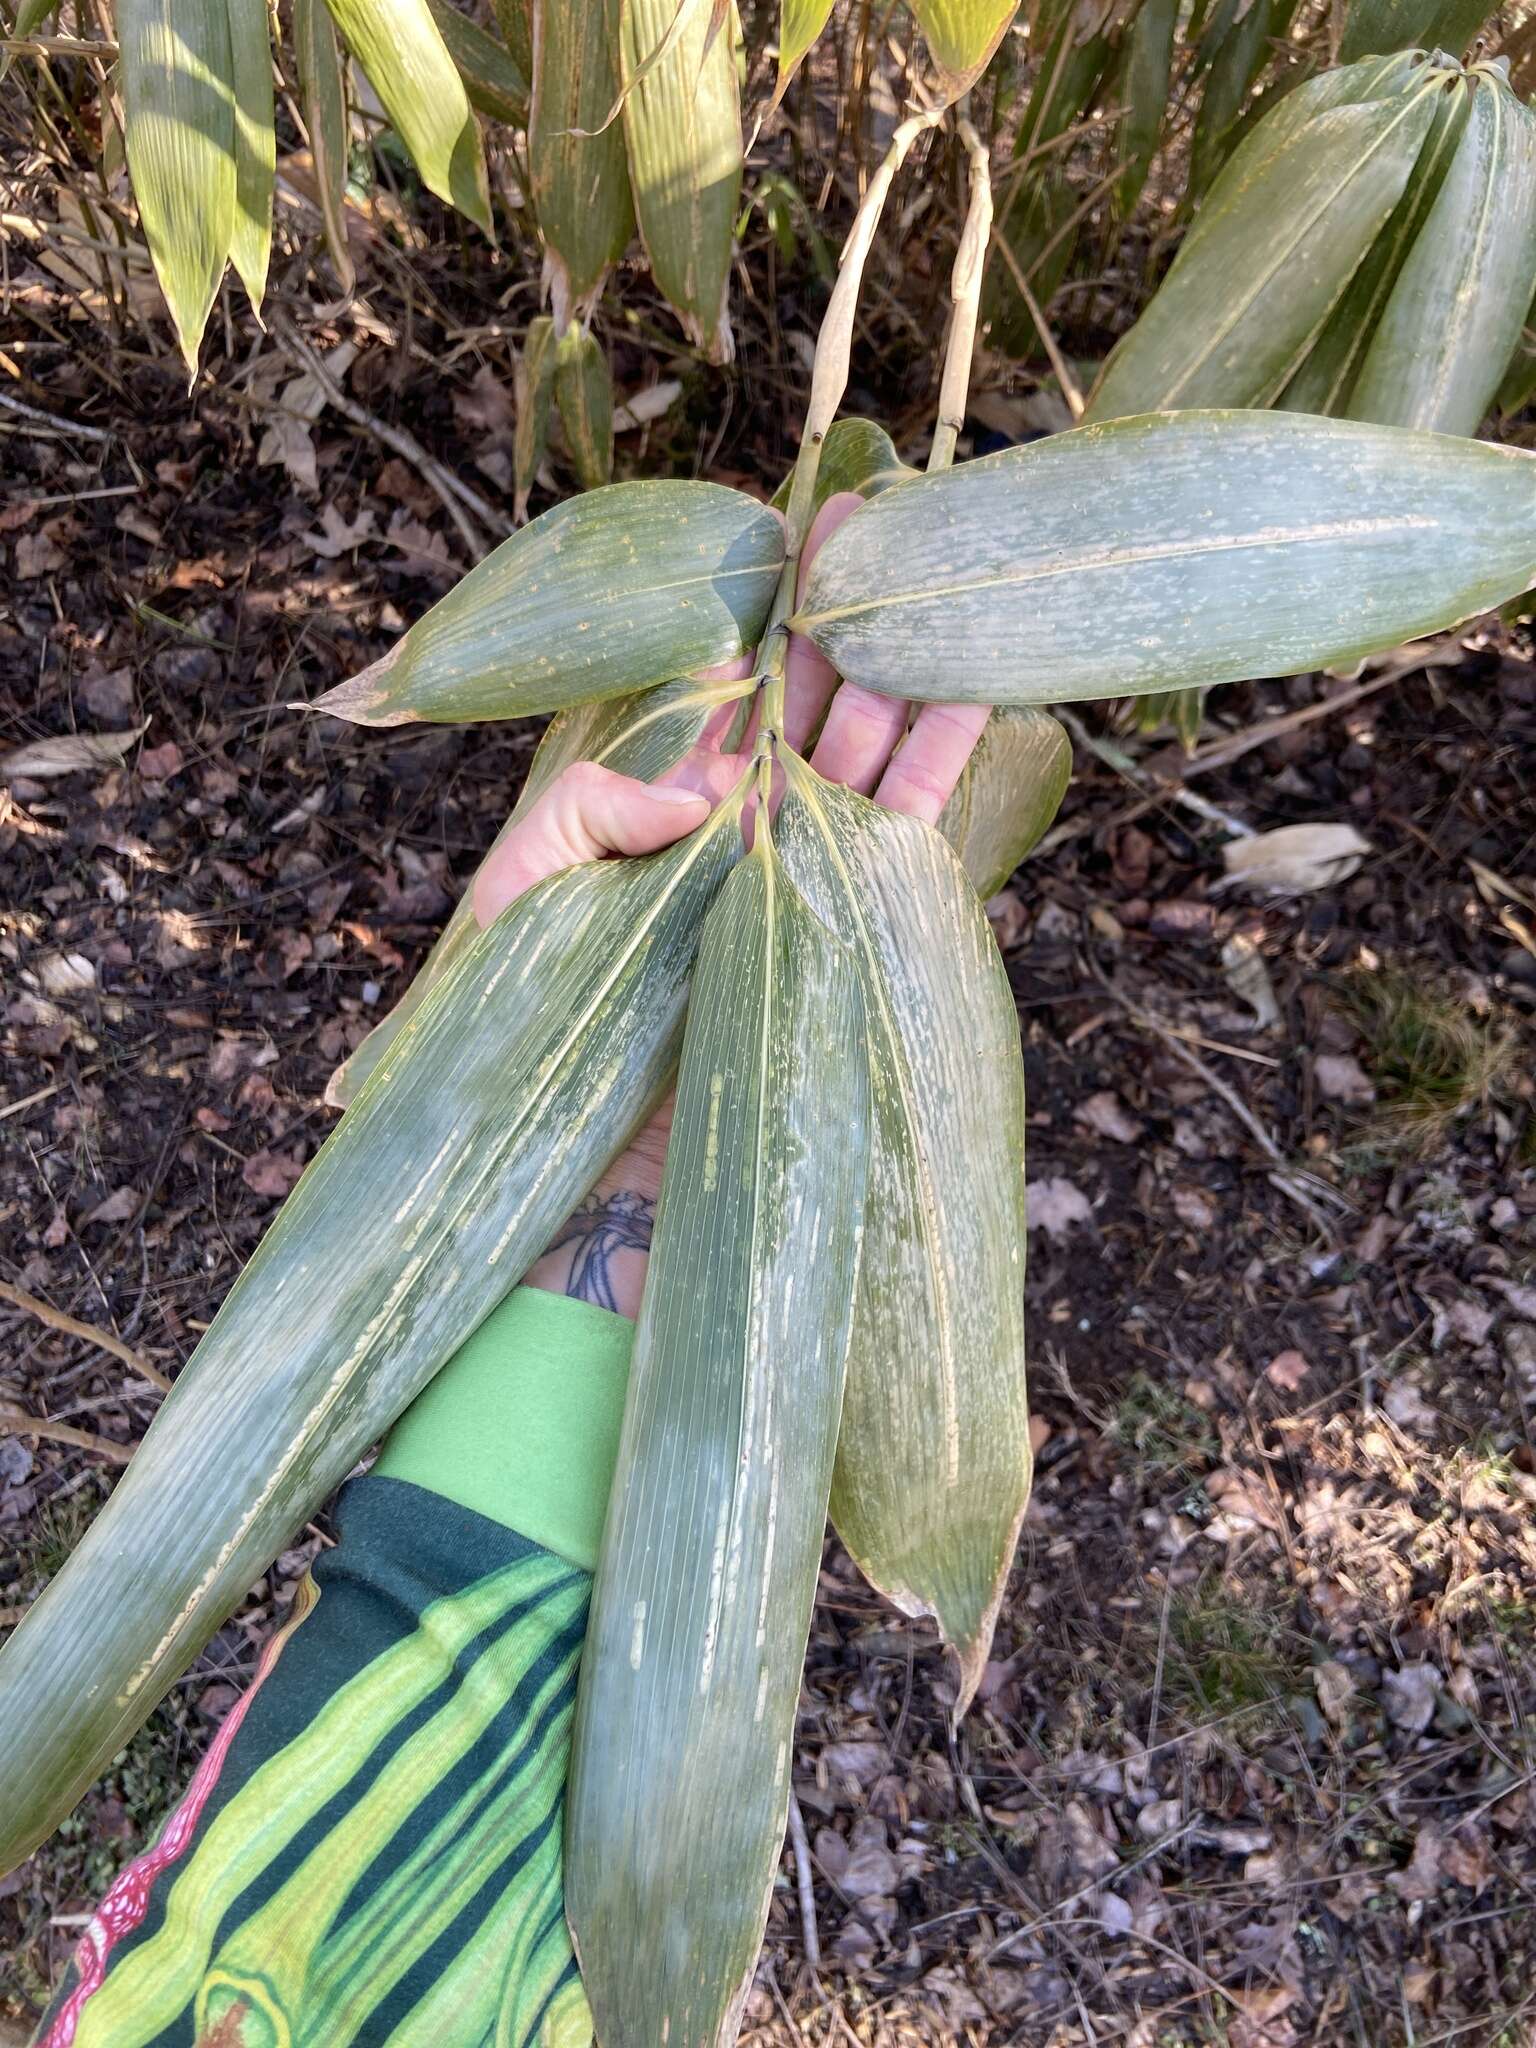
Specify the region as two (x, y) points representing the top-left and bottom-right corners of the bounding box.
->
(35, 1475), (592, 2048)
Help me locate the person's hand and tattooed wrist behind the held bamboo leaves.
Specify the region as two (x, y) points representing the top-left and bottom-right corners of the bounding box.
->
(473, 492), (987, 1317)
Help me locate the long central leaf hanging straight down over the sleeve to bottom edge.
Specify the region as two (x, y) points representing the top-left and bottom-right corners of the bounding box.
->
(565, 840), (868, 2048)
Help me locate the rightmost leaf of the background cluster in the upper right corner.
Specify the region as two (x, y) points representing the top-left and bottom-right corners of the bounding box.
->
(1348, 70), (1536, 434)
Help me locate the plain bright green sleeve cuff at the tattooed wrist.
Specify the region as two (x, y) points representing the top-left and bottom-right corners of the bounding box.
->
(373, 1286), (635, 1571)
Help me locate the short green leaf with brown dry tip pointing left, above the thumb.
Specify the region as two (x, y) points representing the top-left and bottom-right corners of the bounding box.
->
(313, 481), (784, 725)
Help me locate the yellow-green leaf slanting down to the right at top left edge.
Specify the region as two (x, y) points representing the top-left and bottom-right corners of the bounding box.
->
(328, 0), (492, 236)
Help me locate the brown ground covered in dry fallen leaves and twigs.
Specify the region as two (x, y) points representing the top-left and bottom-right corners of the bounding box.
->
(0, 228), (1536, 2048)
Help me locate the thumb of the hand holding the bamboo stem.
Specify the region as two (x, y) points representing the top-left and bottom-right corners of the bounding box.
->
(473, 762), (709, 926)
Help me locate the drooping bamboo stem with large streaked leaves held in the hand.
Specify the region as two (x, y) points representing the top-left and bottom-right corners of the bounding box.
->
(0, 88), (1536, 2048)
